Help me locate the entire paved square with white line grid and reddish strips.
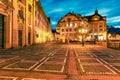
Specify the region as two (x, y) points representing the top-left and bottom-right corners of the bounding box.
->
(0, 43), (120, 80)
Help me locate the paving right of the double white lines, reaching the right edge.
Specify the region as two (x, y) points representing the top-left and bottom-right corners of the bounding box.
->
(88, 47), (120, 74)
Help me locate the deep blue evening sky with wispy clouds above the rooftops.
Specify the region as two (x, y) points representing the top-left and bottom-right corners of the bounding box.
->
(40, 0), (120, 29)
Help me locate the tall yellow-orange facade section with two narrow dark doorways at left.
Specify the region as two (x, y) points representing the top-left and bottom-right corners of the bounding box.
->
(12, 0), (33, 47)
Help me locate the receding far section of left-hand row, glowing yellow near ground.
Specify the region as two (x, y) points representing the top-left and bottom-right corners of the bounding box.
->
(34, 2), (52, 44)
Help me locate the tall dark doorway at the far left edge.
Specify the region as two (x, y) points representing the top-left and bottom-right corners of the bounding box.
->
(0, 14), (4, 48)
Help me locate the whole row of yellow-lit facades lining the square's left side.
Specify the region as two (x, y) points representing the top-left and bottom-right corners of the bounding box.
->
(0, 0), (52, 48)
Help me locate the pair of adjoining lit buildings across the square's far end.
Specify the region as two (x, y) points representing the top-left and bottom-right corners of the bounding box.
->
(56, 10), (107, 42)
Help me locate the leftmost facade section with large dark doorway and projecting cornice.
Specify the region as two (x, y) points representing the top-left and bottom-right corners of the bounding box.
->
(0, 0), (14, 48)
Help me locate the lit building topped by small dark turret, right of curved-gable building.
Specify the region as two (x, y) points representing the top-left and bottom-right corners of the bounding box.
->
(86, 10), (107, 41)
